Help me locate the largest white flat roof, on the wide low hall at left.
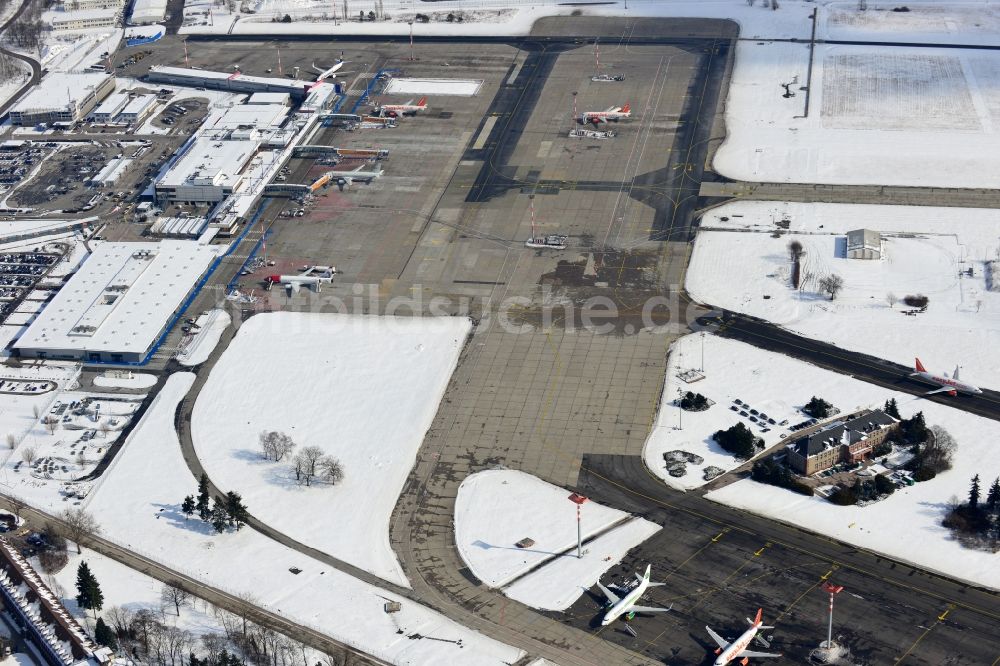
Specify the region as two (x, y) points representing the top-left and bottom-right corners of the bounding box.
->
(15, 240), (217, 354)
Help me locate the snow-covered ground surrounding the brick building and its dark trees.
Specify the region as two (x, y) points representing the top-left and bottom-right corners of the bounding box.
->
(645, 335), (1000, 588)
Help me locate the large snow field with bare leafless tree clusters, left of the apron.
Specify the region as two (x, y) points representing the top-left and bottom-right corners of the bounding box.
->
(192, 312), (471, 585)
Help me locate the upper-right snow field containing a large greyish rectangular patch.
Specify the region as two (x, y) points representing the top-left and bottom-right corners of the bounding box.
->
(715, 41), (1000, 188)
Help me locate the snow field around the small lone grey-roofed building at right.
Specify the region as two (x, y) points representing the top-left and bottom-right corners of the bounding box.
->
(686, 201), (1000, 388)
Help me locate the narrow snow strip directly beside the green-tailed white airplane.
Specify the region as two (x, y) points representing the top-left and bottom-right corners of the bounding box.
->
(503, 518), (662, 611)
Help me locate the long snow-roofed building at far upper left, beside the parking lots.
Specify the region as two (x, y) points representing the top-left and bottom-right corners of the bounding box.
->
(10, 72), (115, 127)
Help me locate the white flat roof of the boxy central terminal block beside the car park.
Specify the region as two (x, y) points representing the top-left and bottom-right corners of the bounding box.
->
(157, 137), (260, 187)
